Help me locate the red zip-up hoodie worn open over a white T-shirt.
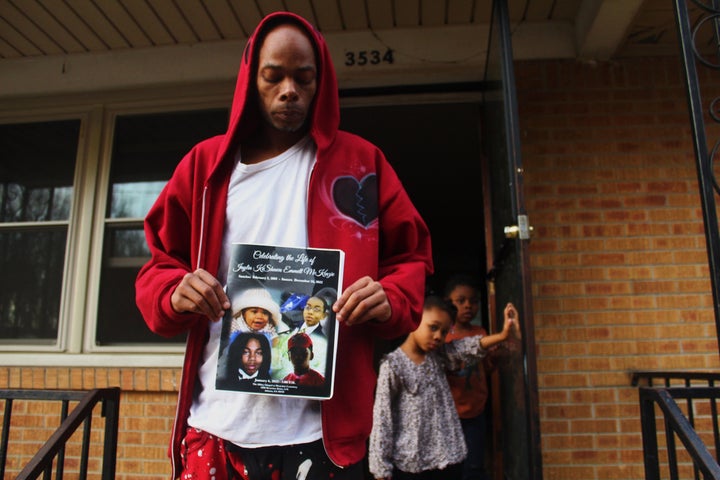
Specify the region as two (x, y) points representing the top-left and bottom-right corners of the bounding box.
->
(136, 12), (432, 478)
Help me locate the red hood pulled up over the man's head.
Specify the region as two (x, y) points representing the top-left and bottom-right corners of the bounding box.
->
(217, 12), (340, 171)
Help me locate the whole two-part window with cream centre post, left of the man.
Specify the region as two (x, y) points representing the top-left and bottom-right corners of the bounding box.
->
(0, 108), (228, 353)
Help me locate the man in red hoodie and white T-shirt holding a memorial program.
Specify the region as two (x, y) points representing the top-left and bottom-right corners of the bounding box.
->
(136, 12), (432, 480)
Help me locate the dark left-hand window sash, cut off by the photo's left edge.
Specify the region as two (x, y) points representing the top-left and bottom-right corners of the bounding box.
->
(0, 120), (80, 345)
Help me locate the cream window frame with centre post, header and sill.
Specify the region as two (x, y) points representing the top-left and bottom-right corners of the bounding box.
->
(0, 84), (232, 367)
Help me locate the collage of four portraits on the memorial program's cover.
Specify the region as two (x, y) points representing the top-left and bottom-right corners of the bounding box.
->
(215, 286), (337, 397)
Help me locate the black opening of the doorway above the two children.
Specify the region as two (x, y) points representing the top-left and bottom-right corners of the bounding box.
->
(340, 102), (487, 296)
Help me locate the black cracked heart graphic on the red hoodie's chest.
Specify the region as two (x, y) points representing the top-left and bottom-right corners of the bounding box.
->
(333, 173), (378, 227)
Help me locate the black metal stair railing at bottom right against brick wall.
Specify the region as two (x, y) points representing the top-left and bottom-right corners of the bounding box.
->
(632, 371), (720, 480)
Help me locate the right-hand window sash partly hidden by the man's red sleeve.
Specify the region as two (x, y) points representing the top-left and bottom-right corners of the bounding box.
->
(95, 109), (228, 346)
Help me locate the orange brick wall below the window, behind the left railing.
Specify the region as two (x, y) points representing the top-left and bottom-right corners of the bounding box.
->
(0, 367), (180, 480)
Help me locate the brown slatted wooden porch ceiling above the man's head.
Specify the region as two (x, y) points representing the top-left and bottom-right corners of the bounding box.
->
(0, 0), (692, 62)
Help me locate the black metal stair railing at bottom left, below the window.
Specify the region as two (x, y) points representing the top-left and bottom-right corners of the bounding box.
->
(0, 387), (120, 480)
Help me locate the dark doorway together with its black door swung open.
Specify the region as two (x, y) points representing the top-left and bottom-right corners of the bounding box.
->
(341, 4), (542, 480)
